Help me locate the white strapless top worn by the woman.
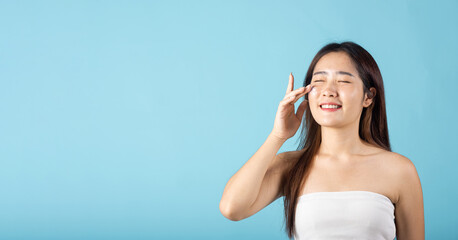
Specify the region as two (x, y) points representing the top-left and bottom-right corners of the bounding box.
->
(294, 191), (396, 240)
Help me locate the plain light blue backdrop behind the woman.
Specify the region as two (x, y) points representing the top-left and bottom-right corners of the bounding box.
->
(0, 1), (458, 239)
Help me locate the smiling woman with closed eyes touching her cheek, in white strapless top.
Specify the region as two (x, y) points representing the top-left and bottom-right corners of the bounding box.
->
(220, 42), (425, 240)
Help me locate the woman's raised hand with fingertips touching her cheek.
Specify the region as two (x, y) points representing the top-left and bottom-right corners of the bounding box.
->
(271, 73), (311, 141)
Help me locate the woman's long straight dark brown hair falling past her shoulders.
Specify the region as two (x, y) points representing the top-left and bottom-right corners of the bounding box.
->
(282, 41), (391, 238)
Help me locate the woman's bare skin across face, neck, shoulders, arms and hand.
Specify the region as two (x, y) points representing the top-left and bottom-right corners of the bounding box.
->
(220, 52), (424, 240)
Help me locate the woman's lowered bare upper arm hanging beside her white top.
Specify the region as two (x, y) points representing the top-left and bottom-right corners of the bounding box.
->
(395, 155), (425, 240)
